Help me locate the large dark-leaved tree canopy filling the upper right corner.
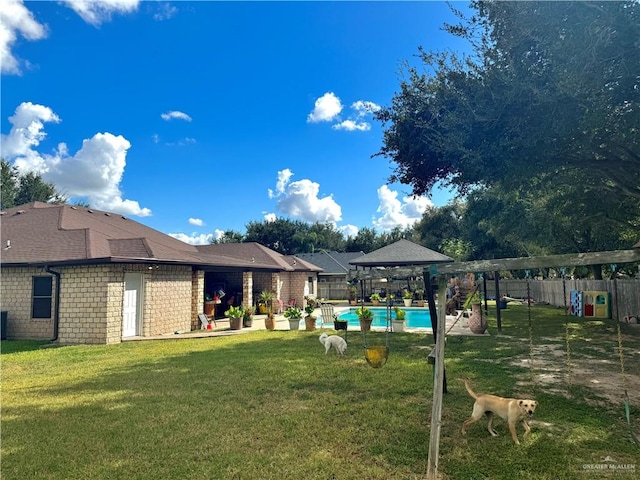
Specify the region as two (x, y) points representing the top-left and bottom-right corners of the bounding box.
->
(378, 1), (640, 215)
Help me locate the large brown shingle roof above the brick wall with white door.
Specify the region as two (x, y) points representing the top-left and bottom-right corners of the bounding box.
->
(0, 202), (287, 270)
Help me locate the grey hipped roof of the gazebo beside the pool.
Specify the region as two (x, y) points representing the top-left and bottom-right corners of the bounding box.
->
(349, 239), (453, 267)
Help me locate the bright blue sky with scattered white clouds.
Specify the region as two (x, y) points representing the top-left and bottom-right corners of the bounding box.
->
(0, 0), (466, 244)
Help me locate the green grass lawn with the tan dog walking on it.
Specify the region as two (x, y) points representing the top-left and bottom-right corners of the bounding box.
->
(0, 305), (640, 480)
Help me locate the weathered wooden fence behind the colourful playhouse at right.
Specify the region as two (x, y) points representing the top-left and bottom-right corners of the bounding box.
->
(487, 278), (640, 320)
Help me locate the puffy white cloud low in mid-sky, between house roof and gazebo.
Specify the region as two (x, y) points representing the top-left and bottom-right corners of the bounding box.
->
(269, 169), (342, 223)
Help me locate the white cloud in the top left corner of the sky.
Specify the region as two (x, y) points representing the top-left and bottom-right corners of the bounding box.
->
(0, 0), (47, 75)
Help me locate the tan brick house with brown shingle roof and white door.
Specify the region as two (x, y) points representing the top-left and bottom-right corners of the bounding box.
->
(0, 202), (321, 344)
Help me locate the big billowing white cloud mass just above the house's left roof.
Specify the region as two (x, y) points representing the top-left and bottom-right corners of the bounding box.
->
(0, 102), (151, 217)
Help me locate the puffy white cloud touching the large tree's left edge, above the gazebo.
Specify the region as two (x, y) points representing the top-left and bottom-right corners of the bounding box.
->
(373, 185), (433, 230)
